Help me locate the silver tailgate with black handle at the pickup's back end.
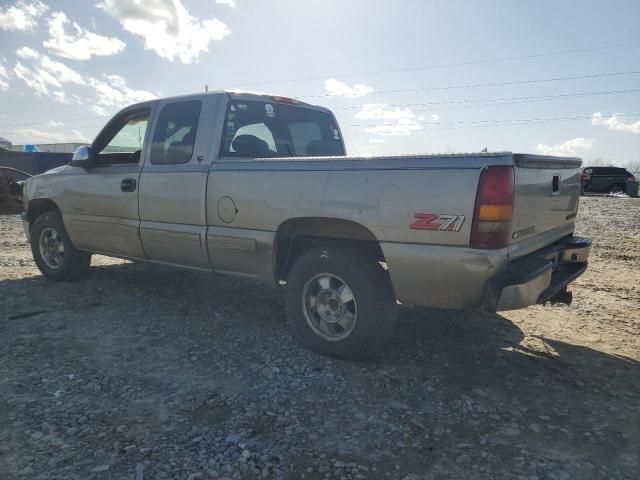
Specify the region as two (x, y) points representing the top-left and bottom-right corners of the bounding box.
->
(510, 154), (582, 251)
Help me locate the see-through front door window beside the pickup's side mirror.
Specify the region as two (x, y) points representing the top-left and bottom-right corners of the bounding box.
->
(98, 110), (149, 164)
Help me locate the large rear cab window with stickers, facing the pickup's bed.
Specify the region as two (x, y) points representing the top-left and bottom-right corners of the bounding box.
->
(221, 100), (344, 158)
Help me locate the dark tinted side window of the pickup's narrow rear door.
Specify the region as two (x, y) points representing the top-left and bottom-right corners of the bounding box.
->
(151, 100), (202, 165)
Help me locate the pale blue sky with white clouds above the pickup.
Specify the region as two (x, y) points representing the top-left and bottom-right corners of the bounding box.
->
(0, 0), (640, 165)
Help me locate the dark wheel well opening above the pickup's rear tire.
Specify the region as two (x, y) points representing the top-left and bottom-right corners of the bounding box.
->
(274, 217), (385, 281)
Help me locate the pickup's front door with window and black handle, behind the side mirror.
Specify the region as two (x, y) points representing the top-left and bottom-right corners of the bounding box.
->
(65, 107), (151, 258)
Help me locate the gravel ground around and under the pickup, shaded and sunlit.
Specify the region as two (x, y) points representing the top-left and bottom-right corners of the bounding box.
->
(0, 198), (640, 480)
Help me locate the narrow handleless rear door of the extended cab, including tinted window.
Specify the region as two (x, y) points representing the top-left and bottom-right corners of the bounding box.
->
(140, 96), (216, 270)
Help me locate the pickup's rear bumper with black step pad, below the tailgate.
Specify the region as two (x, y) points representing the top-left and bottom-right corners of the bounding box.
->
(482, 236), (591, 312)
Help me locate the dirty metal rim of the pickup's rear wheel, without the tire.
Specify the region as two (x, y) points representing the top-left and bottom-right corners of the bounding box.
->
(302, 273), (358, 342)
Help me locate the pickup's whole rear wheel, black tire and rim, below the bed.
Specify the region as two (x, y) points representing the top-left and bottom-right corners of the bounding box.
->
(285, 249), (397, 360)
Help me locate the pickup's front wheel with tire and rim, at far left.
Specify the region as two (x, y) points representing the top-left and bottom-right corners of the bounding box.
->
(31, 212), (91, 281)
